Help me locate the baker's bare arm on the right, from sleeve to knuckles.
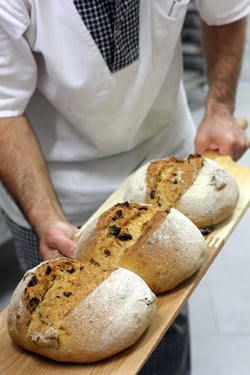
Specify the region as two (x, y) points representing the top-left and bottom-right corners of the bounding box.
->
(195, 18), (250, 160)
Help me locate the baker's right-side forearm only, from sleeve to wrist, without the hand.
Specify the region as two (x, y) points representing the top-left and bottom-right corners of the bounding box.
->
(201, 19), (246, 114)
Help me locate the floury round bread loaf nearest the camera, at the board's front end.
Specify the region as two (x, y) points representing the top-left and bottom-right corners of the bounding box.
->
(8, 258), (156, 363)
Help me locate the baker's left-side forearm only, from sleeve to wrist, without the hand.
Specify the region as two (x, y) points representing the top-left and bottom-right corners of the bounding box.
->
(0, 116), (65, 236)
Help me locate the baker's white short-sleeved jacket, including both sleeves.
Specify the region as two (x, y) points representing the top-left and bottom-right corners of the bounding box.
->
(0, 0), (250, 227)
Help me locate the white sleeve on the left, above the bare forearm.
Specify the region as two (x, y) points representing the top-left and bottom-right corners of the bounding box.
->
(0, 0), (37, 117)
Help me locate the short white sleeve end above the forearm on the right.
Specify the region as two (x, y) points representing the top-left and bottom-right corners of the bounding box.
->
(196, 0), (250, 25)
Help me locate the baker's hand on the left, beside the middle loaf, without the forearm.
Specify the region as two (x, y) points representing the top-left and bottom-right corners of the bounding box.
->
(39, 221), (77, 260)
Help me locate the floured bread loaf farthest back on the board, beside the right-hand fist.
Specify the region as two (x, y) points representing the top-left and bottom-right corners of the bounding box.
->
(124, 154), (239, 228)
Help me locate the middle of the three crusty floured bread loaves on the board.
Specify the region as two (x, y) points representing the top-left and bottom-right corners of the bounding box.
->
(76, 203), (207, 294)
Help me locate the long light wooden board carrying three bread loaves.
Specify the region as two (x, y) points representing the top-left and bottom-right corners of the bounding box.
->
(0, 153), (250, 375)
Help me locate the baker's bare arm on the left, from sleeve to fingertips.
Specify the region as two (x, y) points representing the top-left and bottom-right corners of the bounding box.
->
(0, 116), (76, 259)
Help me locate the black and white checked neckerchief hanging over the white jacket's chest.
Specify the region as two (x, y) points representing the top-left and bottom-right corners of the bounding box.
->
(74, 0), (140, 73)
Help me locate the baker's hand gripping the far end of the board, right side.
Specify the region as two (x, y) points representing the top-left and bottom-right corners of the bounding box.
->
(195, 113), (250, 160)
